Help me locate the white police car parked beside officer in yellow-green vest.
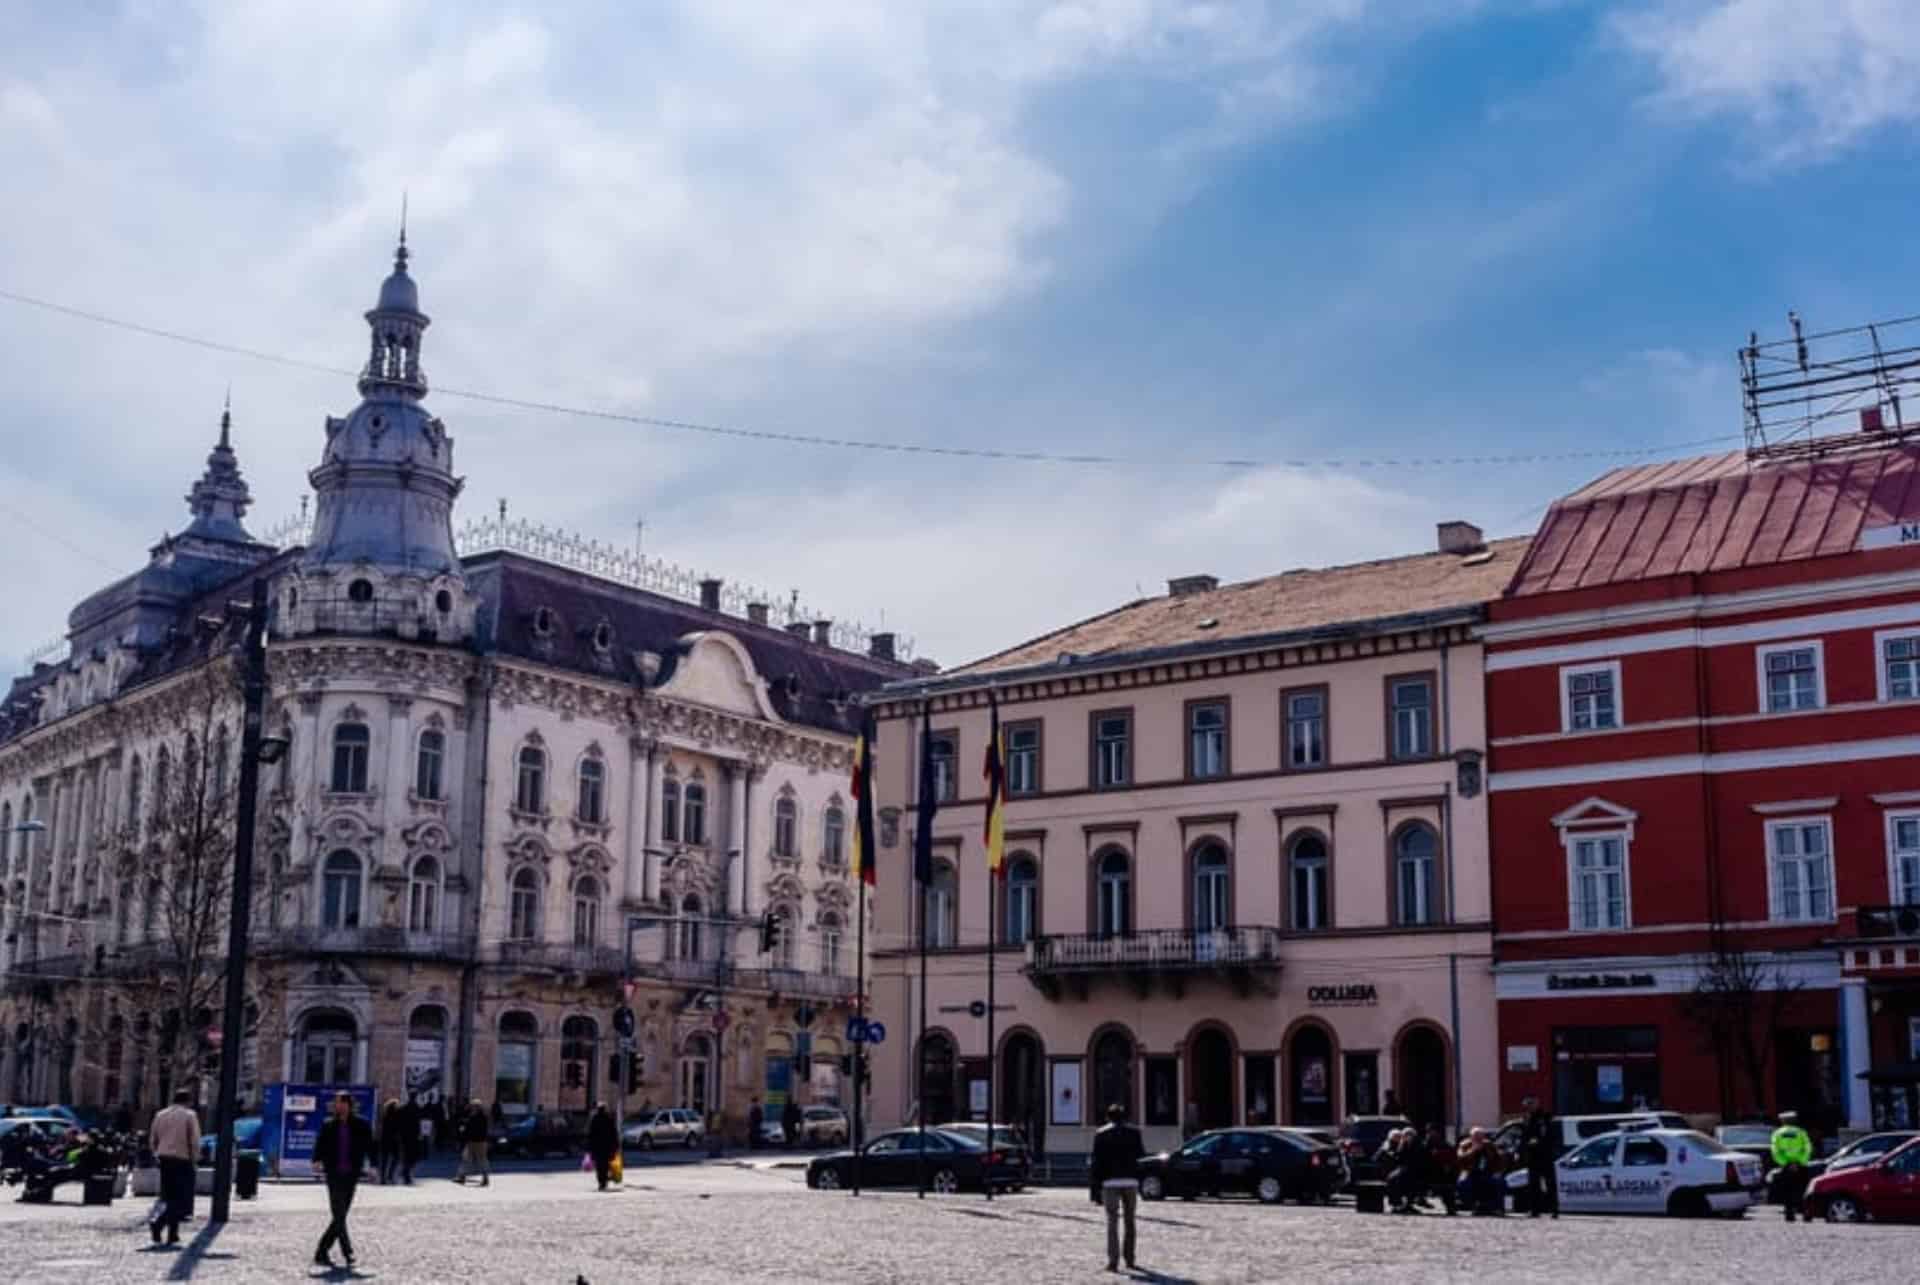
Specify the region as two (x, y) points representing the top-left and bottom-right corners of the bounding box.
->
(1555, 1129), (1766, 1218)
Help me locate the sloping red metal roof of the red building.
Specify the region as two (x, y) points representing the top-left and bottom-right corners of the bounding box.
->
(1507, 437), (1920, 597)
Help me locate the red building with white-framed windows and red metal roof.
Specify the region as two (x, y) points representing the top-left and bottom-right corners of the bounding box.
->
(1486, 436), (1920, 1127)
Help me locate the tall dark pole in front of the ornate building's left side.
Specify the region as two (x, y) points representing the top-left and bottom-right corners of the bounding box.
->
(209, 578), (267, 1224)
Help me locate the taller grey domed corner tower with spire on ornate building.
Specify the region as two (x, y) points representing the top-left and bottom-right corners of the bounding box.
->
(278, 227), (476, 642)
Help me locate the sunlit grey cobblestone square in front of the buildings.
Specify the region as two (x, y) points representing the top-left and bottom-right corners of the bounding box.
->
(0, 1160), (1920, 1285)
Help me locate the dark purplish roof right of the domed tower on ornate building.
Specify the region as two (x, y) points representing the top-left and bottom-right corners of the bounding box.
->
(465, 553), (914, 734)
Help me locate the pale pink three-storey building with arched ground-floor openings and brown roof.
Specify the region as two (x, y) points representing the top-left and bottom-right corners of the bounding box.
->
(870, 522), (1524, 1152)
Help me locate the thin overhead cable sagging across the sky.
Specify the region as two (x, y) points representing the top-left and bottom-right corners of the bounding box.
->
(0, 288), (1741, 471)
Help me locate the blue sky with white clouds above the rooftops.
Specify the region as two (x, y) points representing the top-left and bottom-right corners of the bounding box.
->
(0, 0), (1920, 670)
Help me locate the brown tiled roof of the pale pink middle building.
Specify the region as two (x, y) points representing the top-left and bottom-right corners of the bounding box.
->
(952, 536), (1526, 674)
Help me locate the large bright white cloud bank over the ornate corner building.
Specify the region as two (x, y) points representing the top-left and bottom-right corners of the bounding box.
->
(0, 0), (1476, 668)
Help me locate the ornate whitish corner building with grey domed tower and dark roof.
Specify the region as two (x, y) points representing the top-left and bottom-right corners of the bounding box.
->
(0, 244), (912, 1129)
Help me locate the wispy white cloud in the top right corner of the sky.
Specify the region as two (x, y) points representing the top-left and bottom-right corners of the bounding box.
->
(1615, 0), (1920, 161)
